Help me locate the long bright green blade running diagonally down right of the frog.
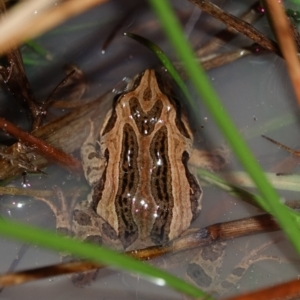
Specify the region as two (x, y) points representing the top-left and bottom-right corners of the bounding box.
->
(149, 0), (300, 253)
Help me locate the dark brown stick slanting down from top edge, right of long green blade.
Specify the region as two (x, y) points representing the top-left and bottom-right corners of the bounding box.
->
(189, 0), (282, 56)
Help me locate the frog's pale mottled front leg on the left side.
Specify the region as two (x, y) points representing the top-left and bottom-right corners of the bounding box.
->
(80, 120), (106, 186)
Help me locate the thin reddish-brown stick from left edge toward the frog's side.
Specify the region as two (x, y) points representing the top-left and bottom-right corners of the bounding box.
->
(0, 118), (82, 171)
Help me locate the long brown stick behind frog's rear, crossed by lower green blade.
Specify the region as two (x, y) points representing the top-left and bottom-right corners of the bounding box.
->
(0, 214), (280, 287)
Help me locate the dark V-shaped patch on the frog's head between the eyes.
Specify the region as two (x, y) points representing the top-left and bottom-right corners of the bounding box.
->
(129, 97), (163, 135)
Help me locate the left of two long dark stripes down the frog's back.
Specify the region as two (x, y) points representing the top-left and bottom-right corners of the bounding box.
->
(115, 124), (139, 248)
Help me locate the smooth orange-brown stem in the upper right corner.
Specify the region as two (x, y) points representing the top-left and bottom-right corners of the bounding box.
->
(264, 0), (300, 105)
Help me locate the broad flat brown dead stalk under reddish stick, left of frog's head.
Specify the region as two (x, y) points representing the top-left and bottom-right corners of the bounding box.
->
(0, 93), (113, 180)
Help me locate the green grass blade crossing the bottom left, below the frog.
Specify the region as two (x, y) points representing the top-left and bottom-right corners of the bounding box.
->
(0, 219), (212, 299)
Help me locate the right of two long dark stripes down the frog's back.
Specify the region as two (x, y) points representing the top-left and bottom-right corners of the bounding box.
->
(150, 126), (174, 245)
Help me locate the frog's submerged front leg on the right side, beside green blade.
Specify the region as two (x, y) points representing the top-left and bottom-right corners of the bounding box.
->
(189, 147), (229, 171)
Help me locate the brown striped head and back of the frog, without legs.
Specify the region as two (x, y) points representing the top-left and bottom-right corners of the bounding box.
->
(93, 70), (202, 248)
